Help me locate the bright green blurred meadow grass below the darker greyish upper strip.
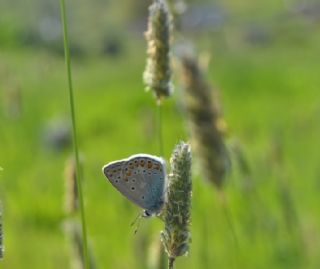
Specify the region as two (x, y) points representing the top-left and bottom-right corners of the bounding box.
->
(0, 13), (320, 269)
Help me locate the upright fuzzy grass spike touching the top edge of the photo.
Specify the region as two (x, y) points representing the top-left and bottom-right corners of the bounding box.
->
(143, 0), (172, 101)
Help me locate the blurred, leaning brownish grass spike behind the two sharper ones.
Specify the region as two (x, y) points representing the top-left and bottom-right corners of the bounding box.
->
(180, 50), (230, 189)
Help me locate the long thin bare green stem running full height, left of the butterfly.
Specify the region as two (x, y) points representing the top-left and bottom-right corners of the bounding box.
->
(60, 0), (89, 269)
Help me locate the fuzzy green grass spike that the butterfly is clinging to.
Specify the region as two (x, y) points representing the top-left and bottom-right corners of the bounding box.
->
(161, 142), (192, 268)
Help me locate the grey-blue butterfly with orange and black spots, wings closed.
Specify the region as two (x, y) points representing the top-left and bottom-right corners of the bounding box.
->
(102, 154), (166, 217)
